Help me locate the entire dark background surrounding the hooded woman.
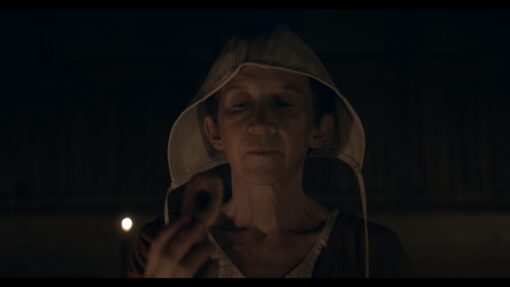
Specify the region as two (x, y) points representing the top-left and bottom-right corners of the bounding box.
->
(0, 9), (510, 277)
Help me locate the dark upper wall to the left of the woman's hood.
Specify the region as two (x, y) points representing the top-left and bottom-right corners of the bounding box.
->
(0, 9), (314, 212)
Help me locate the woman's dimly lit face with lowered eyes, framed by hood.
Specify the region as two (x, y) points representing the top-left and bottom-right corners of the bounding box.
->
(206, 66), (322, 184)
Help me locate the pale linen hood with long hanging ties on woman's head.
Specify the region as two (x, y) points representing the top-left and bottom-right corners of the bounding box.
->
(164, 25), (369, 277)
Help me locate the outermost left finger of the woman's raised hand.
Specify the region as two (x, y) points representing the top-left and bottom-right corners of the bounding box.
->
(145, 217), (190, 276)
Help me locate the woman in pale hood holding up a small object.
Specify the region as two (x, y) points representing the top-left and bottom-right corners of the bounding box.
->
(130, 26), (409, 277)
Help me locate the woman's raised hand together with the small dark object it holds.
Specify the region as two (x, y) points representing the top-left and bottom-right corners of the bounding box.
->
(144, 174), (223, 278)
